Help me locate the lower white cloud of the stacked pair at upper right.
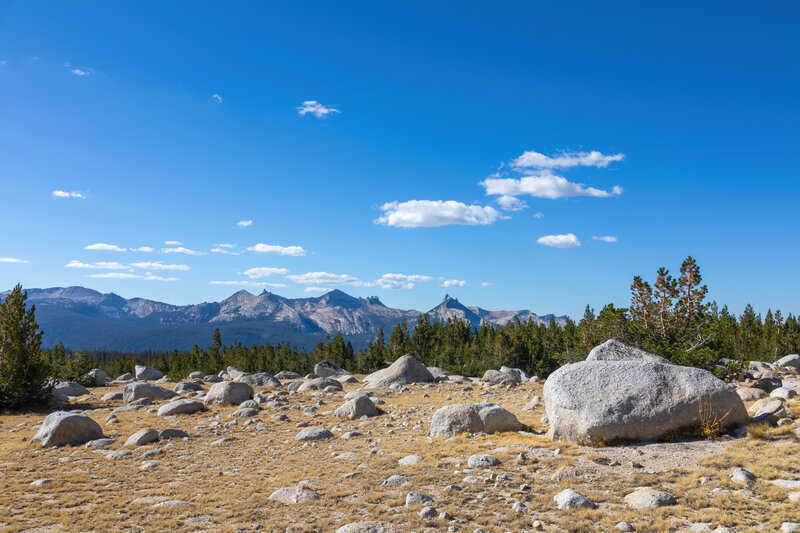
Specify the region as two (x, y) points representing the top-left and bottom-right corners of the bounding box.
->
(481, 171), (622, 200)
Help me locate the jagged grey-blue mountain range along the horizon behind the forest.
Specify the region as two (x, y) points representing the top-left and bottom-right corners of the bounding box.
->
(0, 287), (566, 352)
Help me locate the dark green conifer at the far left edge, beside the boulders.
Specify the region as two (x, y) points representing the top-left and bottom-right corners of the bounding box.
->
(0, 285), (51, 408)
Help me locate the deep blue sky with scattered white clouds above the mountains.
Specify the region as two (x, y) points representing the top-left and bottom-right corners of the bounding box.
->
(0, 0), (800, 317)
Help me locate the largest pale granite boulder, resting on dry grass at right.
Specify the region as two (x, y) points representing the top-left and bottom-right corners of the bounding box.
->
(544, 343), (749, 444)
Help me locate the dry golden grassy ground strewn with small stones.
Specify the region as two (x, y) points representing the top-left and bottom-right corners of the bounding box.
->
(0, 376), (800, 533)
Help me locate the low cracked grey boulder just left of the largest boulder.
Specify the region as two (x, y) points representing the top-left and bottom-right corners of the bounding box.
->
(430, 403), (523, 438)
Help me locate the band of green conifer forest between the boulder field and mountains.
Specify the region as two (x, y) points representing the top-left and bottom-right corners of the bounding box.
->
(46, 257), (800, 379)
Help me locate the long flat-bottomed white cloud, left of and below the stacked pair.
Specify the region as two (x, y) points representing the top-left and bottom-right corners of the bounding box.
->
(375, 200), (503, 228)
